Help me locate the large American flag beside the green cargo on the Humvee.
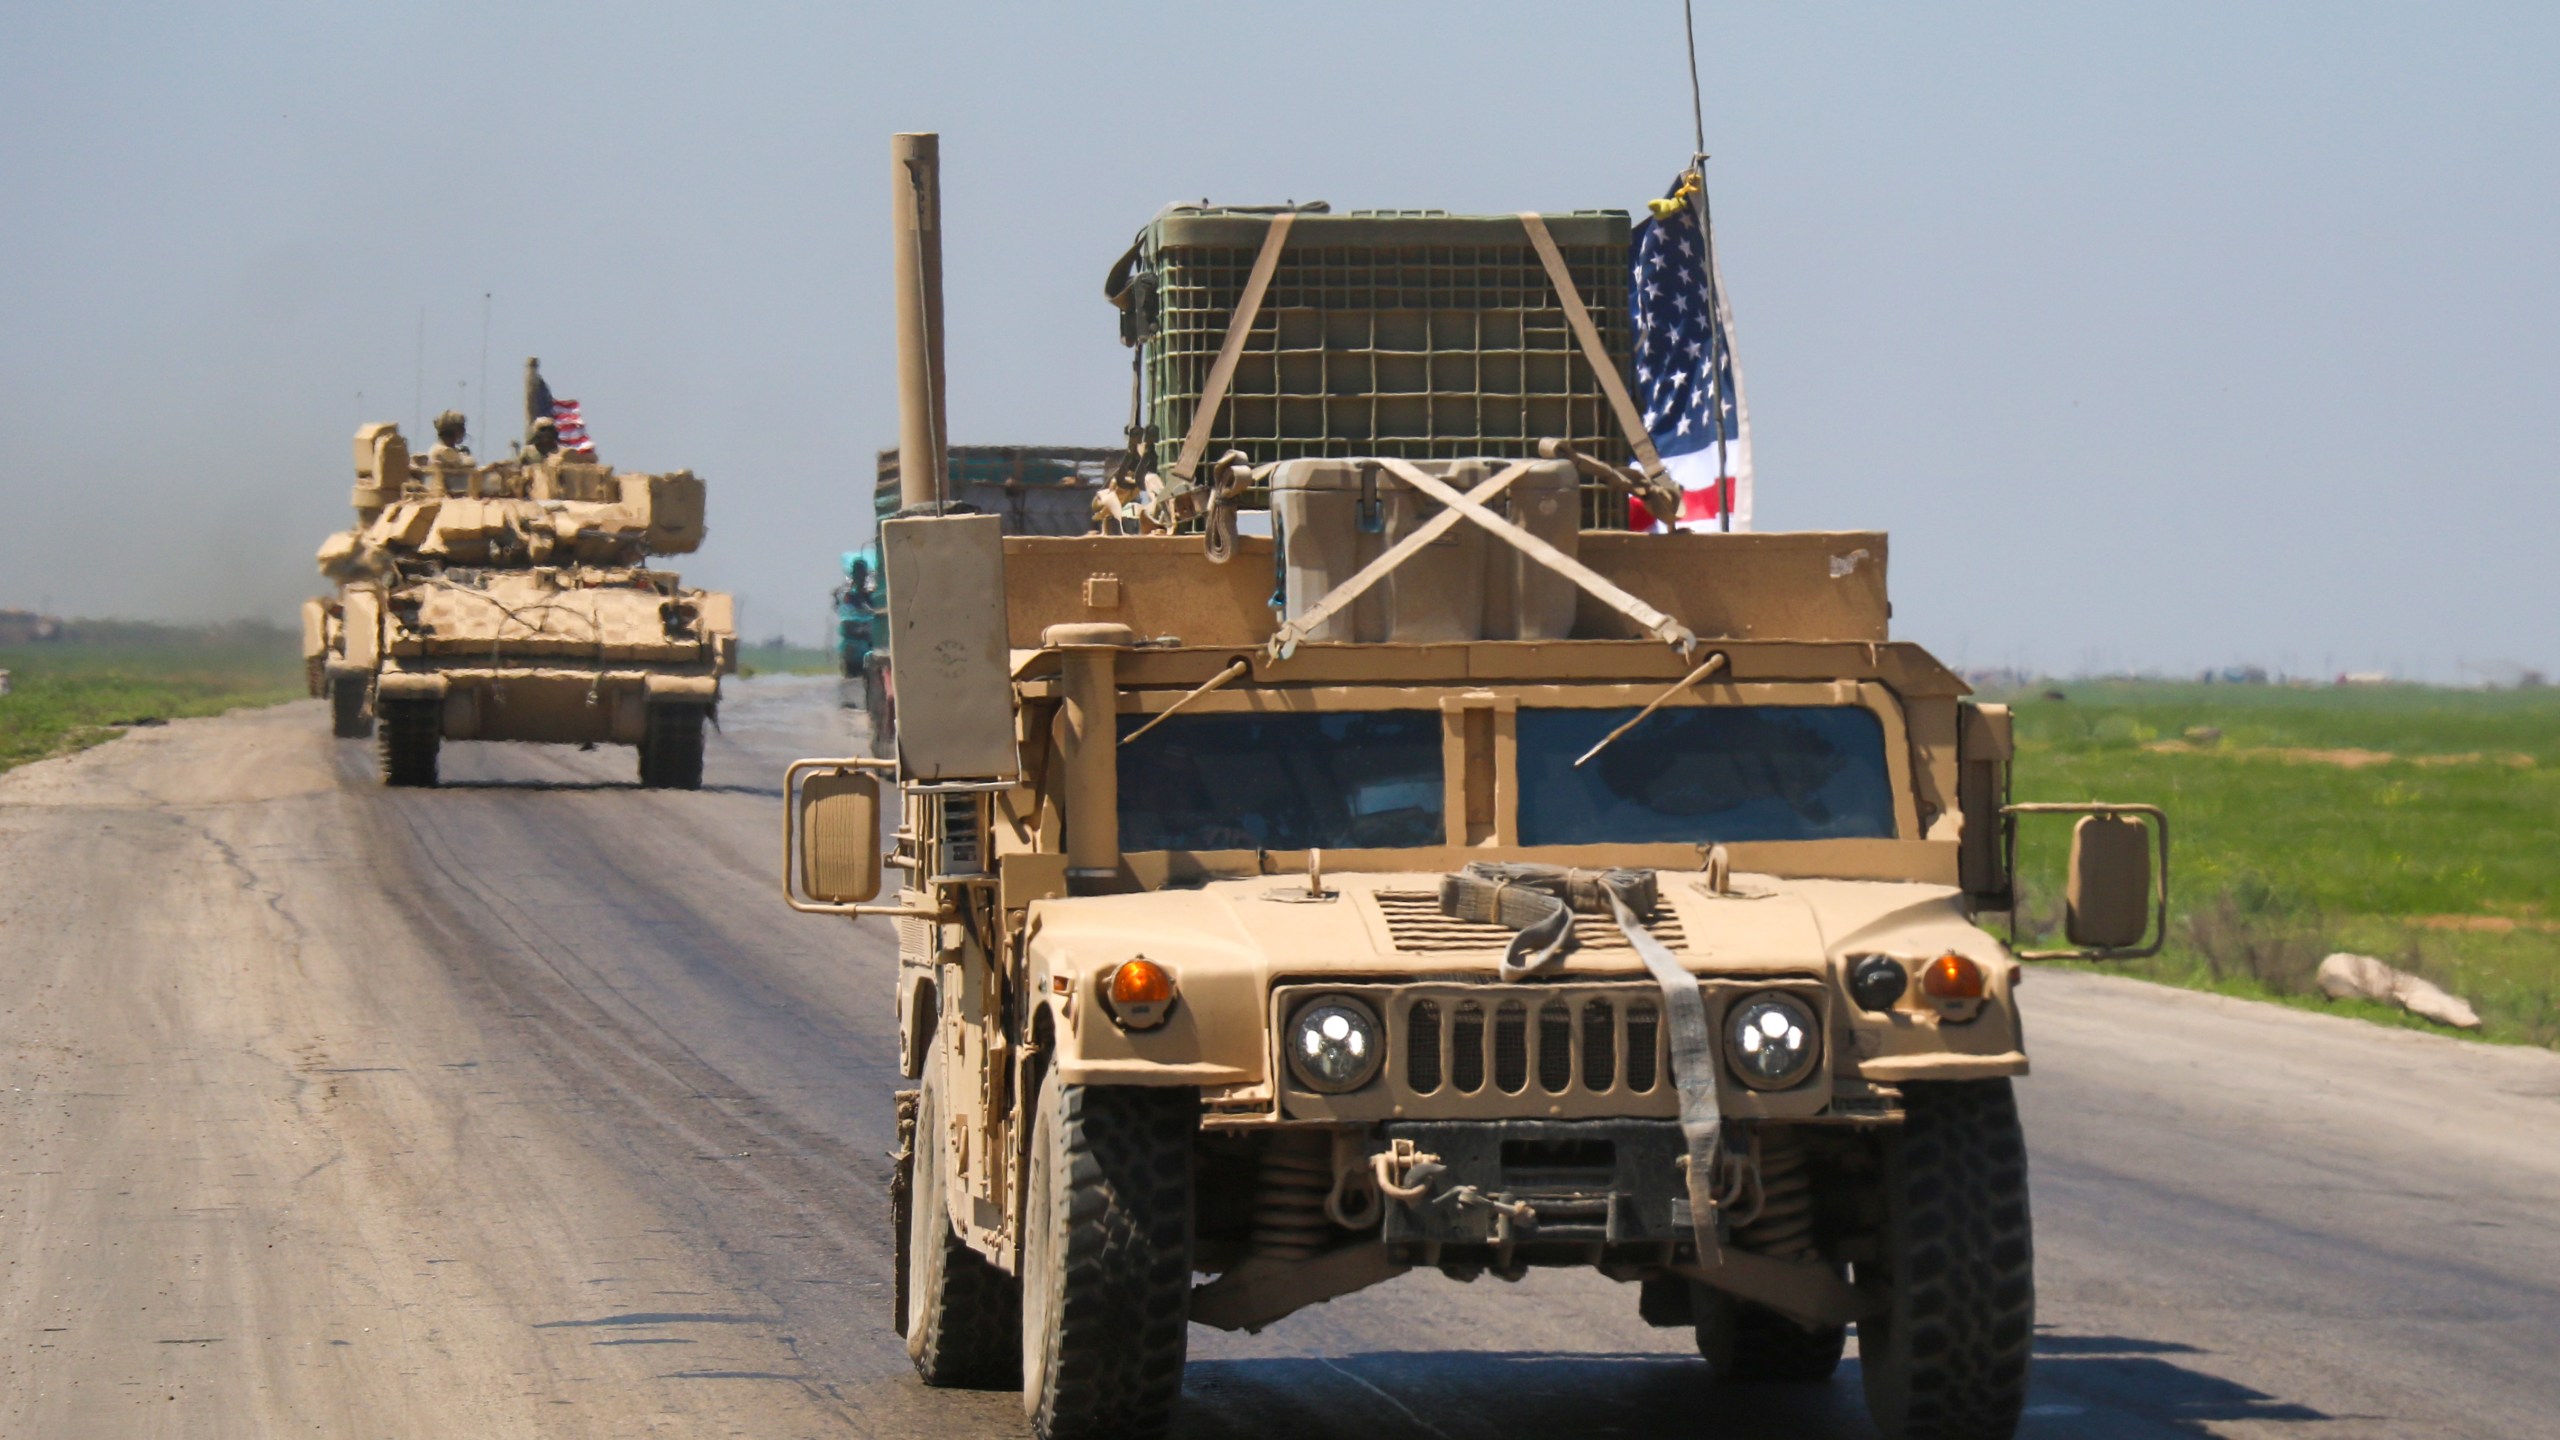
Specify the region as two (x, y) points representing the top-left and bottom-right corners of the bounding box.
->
(1626, 177), (1751, 530)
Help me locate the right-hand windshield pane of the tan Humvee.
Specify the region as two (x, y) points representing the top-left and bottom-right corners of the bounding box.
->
(1518, 705), (1894, 846)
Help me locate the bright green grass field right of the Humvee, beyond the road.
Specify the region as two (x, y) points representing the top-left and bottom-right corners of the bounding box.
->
(1989, 682), (2560, 1045)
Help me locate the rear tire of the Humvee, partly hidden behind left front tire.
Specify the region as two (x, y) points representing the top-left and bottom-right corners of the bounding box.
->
(906, 1040), (1021, 1389)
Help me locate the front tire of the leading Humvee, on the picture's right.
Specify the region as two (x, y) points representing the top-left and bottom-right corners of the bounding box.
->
(1859, 1079), (2035, 1440)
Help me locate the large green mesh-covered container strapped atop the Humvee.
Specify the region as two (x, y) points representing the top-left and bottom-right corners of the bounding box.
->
(1139, 208), (1631, 489)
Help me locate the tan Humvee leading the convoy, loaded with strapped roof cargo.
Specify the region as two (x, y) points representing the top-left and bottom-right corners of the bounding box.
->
(786, 136), (2168, 1440)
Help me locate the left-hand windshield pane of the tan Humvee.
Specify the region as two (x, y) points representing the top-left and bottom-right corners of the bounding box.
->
(1119, 710), (1449, 851)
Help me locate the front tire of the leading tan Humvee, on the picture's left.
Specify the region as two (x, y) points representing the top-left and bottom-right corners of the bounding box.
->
(1021, 1076), (1201, 1440)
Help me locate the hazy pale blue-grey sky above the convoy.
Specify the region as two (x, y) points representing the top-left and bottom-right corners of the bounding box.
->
(0, 0), (2560, 679)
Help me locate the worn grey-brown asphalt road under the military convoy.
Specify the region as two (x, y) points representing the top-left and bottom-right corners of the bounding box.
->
(0, 682), (2560, 1440)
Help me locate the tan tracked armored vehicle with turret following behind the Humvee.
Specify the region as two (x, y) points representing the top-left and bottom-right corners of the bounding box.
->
(302, 397), (737, 789)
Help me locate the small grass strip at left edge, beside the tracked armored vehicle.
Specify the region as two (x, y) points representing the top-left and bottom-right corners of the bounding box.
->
(0, 620), (302, 771)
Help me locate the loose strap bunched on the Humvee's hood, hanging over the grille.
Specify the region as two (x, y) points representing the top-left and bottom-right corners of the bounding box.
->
(1439, 861), (1725, 1266)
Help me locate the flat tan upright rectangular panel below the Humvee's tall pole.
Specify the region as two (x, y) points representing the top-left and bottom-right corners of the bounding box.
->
(881, 515), (1021, 784)
